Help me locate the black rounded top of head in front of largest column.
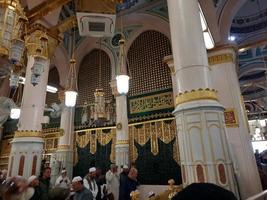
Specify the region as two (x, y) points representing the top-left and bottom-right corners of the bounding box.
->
(172, 183), (237, 200)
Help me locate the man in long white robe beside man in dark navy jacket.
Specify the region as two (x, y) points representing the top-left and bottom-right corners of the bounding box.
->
(106, 164), (120, 200)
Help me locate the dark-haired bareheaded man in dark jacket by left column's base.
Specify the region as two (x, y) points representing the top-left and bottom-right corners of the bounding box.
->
(39, 167), (51, 200)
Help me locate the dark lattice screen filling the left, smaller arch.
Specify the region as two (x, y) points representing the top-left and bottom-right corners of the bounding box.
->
(78, 49), (112, 105)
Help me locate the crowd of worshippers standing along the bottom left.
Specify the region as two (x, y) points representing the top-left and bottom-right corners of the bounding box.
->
(0, 164), (138, 200)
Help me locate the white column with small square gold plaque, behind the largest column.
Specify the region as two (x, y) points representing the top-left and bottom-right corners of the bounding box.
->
(209, 46), (262, 199)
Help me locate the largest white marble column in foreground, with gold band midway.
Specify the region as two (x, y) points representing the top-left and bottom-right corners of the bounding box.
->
(167, 0), (238, 194)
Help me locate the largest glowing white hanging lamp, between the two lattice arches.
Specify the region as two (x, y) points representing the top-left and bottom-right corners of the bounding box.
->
(116, 38), (130, 94)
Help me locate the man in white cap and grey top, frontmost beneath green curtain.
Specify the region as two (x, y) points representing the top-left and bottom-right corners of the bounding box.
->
(72, 176), (94, 200)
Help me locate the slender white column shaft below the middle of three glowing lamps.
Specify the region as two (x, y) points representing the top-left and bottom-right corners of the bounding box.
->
(56, 101), (75, 178)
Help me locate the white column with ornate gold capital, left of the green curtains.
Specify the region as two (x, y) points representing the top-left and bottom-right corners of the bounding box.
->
(8, 28), (57, 178)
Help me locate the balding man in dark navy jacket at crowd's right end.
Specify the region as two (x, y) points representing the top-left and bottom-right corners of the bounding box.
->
(119, 168), (138, 200)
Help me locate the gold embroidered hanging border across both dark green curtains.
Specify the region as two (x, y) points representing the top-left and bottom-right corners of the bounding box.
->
(74, 117), (180, 164)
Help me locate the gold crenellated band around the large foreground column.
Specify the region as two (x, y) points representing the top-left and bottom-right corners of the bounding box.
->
(175, 88), (218, 105)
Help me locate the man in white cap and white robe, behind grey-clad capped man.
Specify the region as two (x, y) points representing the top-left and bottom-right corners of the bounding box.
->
(83, 167), (98, 200)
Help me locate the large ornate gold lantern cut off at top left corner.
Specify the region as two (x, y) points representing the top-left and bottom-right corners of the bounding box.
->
(0, 0), (27, 58)
